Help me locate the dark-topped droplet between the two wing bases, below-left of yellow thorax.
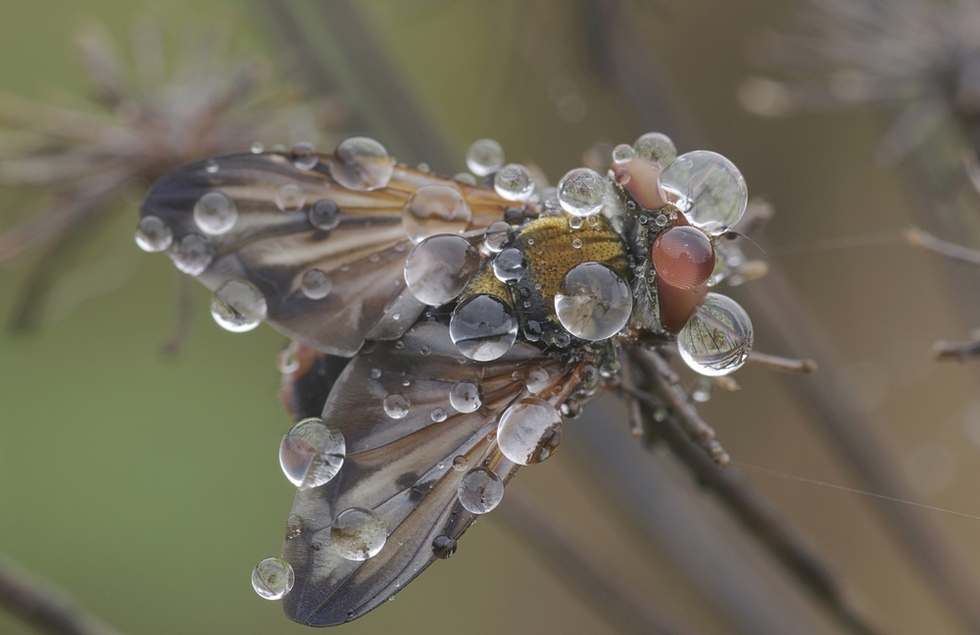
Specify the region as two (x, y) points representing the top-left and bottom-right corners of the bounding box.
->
(449, 295), (517, 362)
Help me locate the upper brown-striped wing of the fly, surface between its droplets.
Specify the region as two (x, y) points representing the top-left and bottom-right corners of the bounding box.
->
(141, 153), (509, 356)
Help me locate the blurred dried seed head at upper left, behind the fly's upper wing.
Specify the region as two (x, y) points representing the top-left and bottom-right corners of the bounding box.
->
(0, 21), (343, 328)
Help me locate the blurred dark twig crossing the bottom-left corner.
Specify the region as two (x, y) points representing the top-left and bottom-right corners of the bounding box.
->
(0, 556), (126, 635)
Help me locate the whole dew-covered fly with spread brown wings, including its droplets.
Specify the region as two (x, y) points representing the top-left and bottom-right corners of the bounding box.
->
(137, 134), (751, 626)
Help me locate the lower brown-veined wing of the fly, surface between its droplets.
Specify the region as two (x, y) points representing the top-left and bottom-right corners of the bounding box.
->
(283, 322), (577, 626)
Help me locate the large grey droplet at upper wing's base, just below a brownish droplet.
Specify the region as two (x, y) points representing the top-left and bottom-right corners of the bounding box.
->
(405, 234), (480, 306)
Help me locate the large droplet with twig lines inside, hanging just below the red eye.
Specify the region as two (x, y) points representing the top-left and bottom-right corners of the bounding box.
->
(677, 293), (752, 377)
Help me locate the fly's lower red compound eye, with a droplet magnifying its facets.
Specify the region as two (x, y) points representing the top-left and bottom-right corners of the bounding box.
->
(650, 226), (715, 333)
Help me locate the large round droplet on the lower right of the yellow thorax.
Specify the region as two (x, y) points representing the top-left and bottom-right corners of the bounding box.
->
(555, 262), (633, 342)
